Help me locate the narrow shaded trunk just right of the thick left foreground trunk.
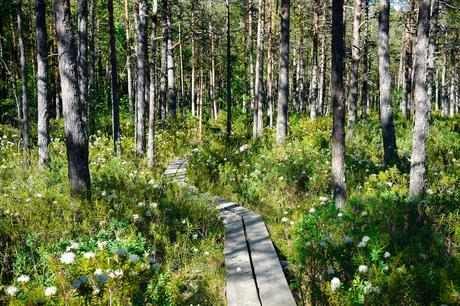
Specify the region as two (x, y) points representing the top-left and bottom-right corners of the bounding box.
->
(88, 0), (96, 135)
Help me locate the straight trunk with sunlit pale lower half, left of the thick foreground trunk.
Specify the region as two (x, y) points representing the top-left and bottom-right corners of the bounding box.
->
(36, 0), (49, 168)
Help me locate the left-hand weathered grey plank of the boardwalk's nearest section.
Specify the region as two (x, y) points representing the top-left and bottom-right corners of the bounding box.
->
(224, 214), (260, 306)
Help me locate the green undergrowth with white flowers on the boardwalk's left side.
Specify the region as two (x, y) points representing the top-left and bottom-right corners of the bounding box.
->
(0, 118), (225, 305)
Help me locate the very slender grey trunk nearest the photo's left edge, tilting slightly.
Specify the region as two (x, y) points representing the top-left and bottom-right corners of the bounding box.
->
(17, 0), (30, 159)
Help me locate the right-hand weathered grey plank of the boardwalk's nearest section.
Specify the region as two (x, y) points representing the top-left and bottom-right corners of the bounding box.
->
(243, 212), (296, 306)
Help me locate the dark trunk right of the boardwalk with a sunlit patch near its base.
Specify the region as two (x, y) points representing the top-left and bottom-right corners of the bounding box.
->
(331, 0), (346, 207)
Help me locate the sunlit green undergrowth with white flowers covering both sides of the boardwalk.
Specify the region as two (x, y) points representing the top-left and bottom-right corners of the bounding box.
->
(0, 114), (460, 305)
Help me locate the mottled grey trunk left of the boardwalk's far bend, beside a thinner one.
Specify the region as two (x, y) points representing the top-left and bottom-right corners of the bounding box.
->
(136, 0), (147, 154)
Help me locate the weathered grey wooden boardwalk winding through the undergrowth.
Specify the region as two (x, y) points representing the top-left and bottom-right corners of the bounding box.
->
(165, 158), (296, 306)
